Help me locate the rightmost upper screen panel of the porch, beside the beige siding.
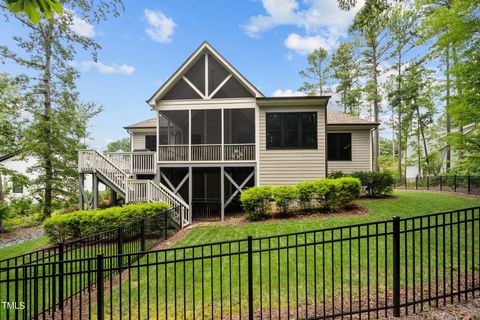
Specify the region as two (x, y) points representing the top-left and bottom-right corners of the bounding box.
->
(223, 109), (255, 144)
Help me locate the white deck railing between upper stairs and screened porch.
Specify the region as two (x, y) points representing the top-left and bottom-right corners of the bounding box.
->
(107, 152), (156, 174)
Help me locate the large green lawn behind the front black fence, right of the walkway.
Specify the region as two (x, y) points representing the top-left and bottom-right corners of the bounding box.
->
(100, 191), (480, 318)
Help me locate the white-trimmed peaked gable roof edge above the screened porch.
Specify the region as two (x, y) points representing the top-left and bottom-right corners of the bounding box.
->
(147, 41), (263, 107)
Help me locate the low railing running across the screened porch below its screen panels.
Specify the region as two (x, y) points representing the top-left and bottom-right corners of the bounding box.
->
(158, 143), (256, 162)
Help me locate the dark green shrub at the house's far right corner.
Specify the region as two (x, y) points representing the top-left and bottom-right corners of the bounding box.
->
(351, 171), (395, 197)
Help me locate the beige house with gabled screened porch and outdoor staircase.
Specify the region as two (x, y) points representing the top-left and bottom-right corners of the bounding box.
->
(79, 42), (378, 226)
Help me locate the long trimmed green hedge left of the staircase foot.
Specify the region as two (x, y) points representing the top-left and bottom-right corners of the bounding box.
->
(43, 203), (169, 242)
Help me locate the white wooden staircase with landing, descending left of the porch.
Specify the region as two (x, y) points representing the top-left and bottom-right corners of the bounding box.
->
(78, 149), (191, 228)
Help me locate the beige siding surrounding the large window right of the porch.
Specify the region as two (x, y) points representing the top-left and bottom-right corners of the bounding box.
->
(259, 106), (325, 185)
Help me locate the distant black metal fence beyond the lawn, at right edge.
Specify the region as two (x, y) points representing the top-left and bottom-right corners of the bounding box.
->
(395, 175), (480, 195)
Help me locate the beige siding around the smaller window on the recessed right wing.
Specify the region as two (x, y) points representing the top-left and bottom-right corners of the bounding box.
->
(327, 127), (372, 172)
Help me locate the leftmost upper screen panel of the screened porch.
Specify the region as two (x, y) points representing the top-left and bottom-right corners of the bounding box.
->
(158, 110), (189, 145)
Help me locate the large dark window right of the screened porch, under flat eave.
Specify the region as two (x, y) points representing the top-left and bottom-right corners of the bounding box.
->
(267, 112), (317, 149)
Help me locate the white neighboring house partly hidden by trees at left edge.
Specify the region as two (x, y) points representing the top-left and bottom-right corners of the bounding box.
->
(0, 155), (35, 199)
